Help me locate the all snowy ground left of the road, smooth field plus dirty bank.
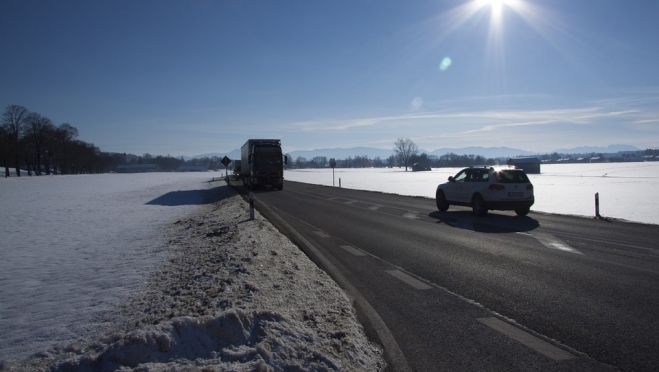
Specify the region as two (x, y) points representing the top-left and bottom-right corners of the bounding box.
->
(0, 173), (384, 371)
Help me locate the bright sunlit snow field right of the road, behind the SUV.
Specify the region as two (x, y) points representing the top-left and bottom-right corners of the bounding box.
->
(285, 162), (659, 225)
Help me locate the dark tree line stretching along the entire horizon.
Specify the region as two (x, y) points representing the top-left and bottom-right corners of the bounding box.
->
(0, 105), (659, 177)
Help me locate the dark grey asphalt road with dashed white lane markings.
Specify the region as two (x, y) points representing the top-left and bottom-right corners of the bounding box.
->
(237, 181), (659, 371)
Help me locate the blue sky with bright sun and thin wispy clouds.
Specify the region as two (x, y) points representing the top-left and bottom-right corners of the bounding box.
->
(0, 0), (659, 156)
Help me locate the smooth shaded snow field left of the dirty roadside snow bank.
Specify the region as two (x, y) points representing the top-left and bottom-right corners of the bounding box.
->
(0, 173), (222, 360)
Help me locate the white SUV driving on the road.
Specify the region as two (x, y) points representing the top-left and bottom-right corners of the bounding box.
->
(435, 167), (535, 216)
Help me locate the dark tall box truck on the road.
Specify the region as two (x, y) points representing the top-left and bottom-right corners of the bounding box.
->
(240, 139), (288, 190)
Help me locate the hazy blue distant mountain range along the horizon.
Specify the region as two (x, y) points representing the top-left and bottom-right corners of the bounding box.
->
(192, 145), (640, 160)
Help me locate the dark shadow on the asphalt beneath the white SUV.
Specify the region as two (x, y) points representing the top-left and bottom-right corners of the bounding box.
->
(428, 211), (540, 234)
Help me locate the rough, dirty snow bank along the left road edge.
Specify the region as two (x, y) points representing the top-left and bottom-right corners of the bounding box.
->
(5, 187), (385, 371)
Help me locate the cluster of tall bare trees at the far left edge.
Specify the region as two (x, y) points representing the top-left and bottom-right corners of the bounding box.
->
(0, 105), (104, 177)
